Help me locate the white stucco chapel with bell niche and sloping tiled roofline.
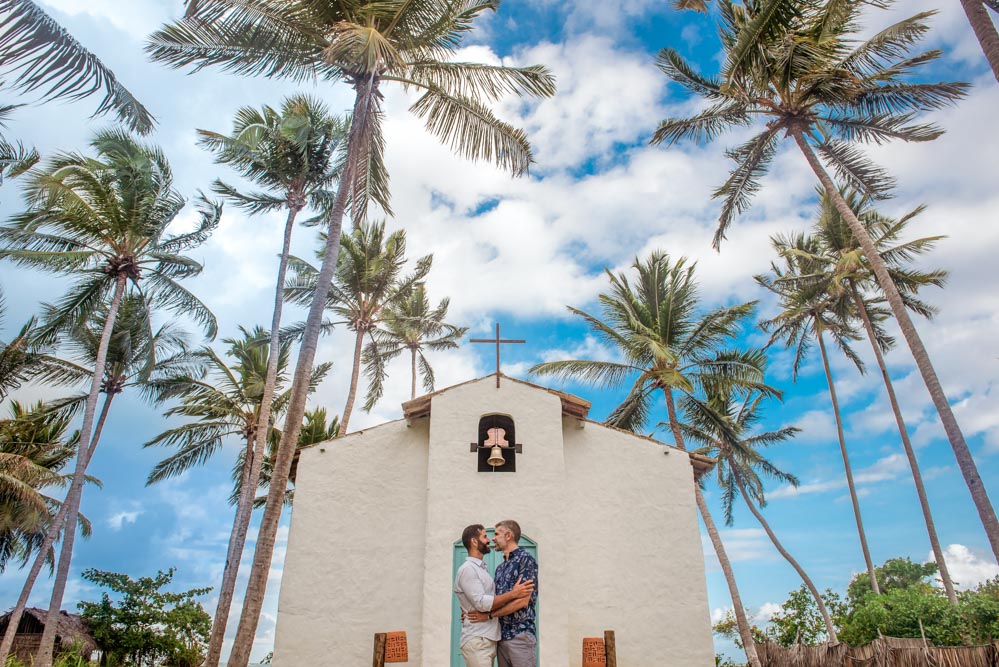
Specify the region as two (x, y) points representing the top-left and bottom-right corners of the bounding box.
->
(273, 374), (714, 667)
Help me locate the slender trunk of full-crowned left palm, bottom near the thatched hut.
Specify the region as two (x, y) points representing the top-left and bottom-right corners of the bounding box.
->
(32, 275), (127, 667)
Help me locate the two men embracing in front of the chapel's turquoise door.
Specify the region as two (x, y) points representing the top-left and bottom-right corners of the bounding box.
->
(454, 520), (538, 667)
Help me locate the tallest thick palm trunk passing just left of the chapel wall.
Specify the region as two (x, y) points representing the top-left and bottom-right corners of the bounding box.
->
(227, 79), (377, 667)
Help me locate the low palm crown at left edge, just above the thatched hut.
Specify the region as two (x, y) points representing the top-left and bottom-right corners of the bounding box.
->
(0, 401), (90, 572)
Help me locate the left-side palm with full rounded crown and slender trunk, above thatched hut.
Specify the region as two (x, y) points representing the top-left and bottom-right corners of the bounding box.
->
(0, 129), (221, 667)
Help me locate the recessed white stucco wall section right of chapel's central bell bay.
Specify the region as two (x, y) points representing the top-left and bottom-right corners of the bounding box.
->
(564, 418), (714, 667)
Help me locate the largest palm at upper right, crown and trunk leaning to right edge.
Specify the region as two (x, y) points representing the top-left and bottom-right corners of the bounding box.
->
(652, 0), (999, 560)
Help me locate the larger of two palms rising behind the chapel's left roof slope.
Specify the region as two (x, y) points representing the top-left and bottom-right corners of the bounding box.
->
(285, 221), (433, 434)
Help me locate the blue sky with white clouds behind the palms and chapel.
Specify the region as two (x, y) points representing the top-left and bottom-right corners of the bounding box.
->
(0, 0), (999, 658)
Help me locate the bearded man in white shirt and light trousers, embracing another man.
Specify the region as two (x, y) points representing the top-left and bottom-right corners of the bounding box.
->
(454, 524), (534, 667)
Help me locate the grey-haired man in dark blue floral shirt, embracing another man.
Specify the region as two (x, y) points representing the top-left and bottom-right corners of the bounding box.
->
(493, 520), (538, 667)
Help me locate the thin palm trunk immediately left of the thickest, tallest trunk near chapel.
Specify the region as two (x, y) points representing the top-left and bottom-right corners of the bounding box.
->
(204, 205), (301, 667)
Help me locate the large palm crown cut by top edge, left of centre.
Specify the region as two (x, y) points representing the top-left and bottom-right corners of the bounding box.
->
(146, 0), (555, 190)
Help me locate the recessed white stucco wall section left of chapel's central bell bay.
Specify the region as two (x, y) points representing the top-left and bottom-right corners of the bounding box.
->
(274, 420), (427, 667)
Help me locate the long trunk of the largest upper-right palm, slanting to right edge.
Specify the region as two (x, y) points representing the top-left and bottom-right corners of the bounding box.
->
(791, 130), (999, 561)
